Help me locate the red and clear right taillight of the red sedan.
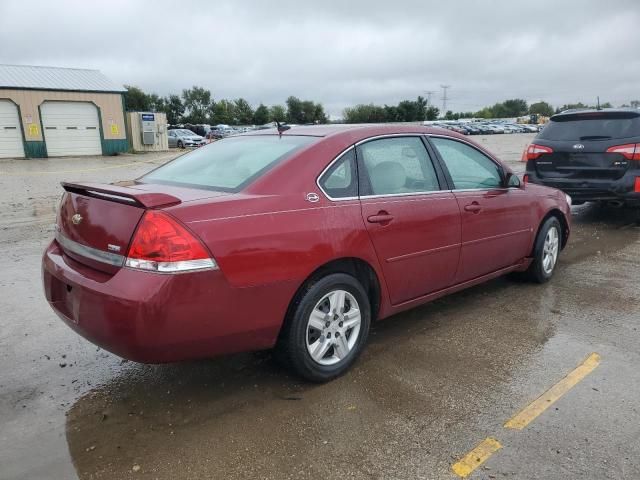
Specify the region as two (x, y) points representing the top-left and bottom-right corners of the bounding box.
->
(125, 210), (218, 273)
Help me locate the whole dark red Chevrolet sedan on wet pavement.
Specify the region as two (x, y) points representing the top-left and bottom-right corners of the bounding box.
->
(43, 126), (570, 381)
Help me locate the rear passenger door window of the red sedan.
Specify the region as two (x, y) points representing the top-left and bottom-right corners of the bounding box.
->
(358, 137), (440, 195)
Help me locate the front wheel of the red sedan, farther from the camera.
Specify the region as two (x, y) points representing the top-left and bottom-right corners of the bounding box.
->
(525, 217), (562, 283)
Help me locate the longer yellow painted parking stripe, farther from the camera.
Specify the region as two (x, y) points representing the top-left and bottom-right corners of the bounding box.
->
(504, 353), (600, 430)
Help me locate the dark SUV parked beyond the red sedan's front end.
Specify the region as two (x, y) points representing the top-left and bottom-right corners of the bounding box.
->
(522, 109), (640, 206)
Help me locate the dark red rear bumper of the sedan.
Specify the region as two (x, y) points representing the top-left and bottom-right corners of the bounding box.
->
(42, 241), (295, 363)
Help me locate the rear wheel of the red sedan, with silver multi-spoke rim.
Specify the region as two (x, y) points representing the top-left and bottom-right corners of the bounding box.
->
(277, 273), (371, 382)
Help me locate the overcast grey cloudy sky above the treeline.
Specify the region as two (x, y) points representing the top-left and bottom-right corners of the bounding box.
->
(0, 0), (640, 118)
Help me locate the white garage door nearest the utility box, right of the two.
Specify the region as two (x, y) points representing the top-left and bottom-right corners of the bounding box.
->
(40, 102), (102, 157)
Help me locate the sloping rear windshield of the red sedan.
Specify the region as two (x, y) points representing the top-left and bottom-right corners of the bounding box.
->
(140, 135), (317, 192)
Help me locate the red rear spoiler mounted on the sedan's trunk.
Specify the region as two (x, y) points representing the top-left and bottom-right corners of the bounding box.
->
(60, 182), (181, 208)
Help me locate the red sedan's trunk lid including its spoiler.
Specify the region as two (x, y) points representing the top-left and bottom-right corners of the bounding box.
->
(56, 182), (224, 273)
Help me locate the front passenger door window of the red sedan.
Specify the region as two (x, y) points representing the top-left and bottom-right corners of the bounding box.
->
(430, 137), (502, 190)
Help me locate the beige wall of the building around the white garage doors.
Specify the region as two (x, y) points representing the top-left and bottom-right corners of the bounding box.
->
(0, 89), (127, 142)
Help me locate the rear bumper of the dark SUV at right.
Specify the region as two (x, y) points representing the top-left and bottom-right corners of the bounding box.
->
(526, 170), (640, 205)
